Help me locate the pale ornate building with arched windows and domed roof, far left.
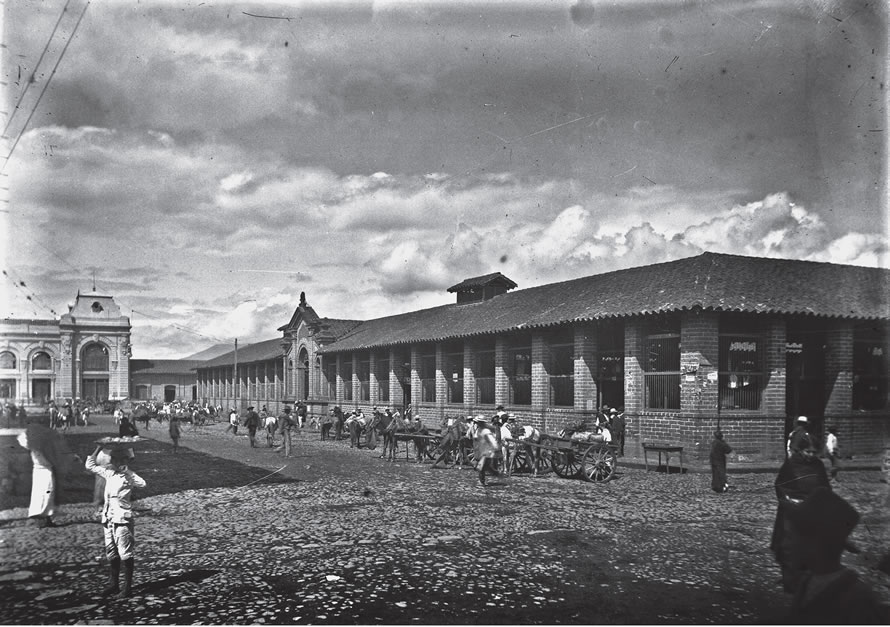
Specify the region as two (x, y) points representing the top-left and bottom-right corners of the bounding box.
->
(0, 292), (130, 407)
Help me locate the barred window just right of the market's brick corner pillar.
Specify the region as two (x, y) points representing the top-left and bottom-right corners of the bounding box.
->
(718, 334), (764, 409)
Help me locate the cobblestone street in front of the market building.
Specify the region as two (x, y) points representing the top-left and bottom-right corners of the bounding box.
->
(0, 417), (890, 624)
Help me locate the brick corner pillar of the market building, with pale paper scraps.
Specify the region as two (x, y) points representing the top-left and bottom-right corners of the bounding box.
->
(680, 309), (720, 418)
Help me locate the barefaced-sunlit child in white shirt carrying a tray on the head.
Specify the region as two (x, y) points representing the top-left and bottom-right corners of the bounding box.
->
(86, 445), (145, 599)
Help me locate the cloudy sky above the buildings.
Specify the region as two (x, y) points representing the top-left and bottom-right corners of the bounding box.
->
(0, 0), (890, 359)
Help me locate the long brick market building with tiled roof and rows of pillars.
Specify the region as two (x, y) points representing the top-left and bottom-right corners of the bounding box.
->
(191, 253), (890, 459)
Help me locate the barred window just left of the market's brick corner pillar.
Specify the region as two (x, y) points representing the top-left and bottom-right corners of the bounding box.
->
(643, 321), (680, 409)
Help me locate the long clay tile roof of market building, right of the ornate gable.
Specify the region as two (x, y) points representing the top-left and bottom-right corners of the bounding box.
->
(321, 253), (890, 353)
